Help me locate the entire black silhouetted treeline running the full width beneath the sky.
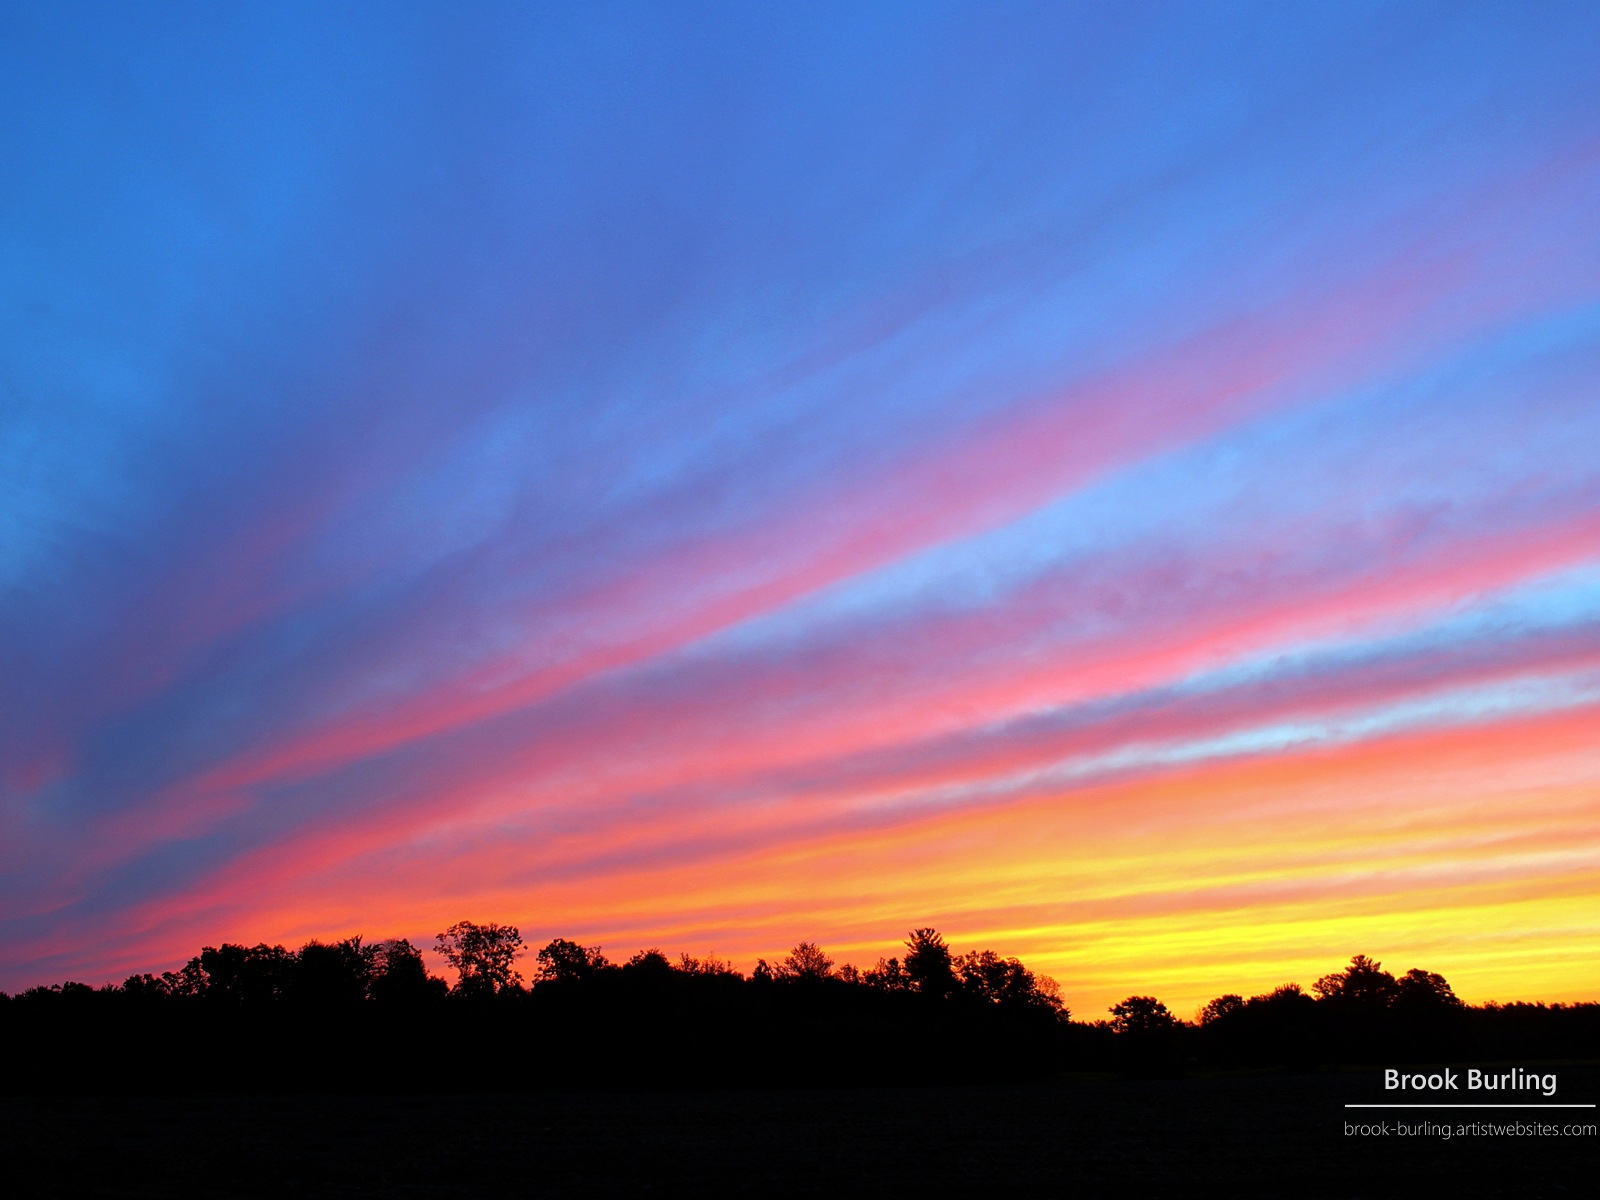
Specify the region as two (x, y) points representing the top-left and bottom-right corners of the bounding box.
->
(0, 922), (1600, 1091)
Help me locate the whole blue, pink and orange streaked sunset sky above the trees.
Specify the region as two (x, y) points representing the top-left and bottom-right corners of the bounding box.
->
(0, 0), (1600, 1016)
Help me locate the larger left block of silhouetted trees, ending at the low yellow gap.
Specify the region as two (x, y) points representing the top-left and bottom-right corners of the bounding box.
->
(0, 922), (1067, 1091)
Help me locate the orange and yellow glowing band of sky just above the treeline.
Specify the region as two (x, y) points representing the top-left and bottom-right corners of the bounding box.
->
(50, 709), (1600, 1019)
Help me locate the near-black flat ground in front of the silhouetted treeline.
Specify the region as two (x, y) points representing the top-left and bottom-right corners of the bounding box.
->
(0, 1066), (1600, 1197)
